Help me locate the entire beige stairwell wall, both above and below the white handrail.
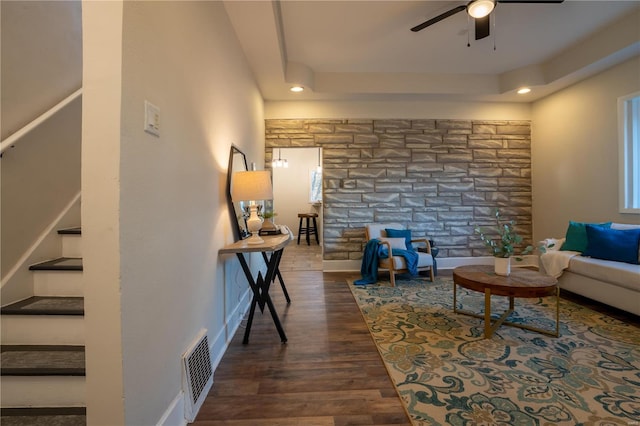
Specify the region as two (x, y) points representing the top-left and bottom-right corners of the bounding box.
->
(0, 1), (82, 304)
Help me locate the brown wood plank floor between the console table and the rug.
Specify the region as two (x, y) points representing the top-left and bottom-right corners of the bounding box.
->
(194, 242), (410, 426)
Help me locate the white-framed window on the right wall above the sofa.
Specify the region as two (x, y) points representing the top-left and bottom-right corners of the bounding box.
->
(618, 92), (640, 214)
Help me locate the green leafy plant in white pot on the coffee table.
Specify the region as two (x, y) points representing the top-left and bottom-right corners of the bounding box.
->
(474, 209), (533, 275)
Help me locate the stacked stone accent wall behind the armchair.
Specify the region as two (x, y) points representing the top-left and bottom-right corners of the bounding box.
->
(266, 119), (531, 260)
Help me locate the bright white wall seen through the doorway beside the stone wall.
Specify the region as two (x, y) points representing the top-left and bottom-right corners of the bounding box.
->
(272, 148), (322, 238)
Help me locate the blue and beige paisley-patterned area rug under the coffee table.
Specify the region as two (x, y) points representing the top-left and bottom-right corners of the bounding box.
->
(349, 278), (640, 426)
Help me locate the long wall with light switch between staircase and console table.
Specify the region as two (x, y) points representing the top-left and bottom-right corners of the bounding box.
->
(83, 1), (264, 425)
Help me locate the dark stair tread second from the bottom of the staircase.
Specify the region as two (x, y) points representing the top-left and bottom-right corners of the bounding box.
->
(0, 345), (85, 376)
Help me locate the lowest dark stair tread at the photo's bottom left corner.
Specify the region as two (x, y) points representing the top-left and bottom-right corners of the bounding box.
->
(0, 407), (87, 426)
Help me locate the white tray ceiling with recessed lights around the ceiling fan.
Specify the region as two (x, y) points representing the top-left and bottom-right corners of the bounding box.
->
(225, 0), (640, 102)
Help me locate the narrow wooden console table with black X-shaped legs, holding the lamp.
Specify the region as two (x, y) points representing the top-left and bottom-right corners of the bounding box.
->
(218, 232), (293, 344)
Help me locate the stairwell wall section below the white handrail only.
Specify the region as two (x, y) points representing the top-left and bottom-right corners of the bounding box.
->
(0, 98), (82, 305)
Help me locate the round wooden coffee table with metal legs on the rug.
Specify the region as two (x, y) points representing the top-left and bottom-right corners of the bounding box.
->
(453, 265), (560, 339)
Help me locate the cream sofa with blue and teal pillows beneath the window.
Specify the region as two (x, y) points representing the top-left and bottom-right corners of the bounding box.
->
(540, 222), (640, 315)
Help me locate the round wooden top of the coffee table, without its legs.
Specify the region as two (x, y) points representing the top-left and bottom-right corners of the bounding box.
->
(453, 265), (558, 297)
